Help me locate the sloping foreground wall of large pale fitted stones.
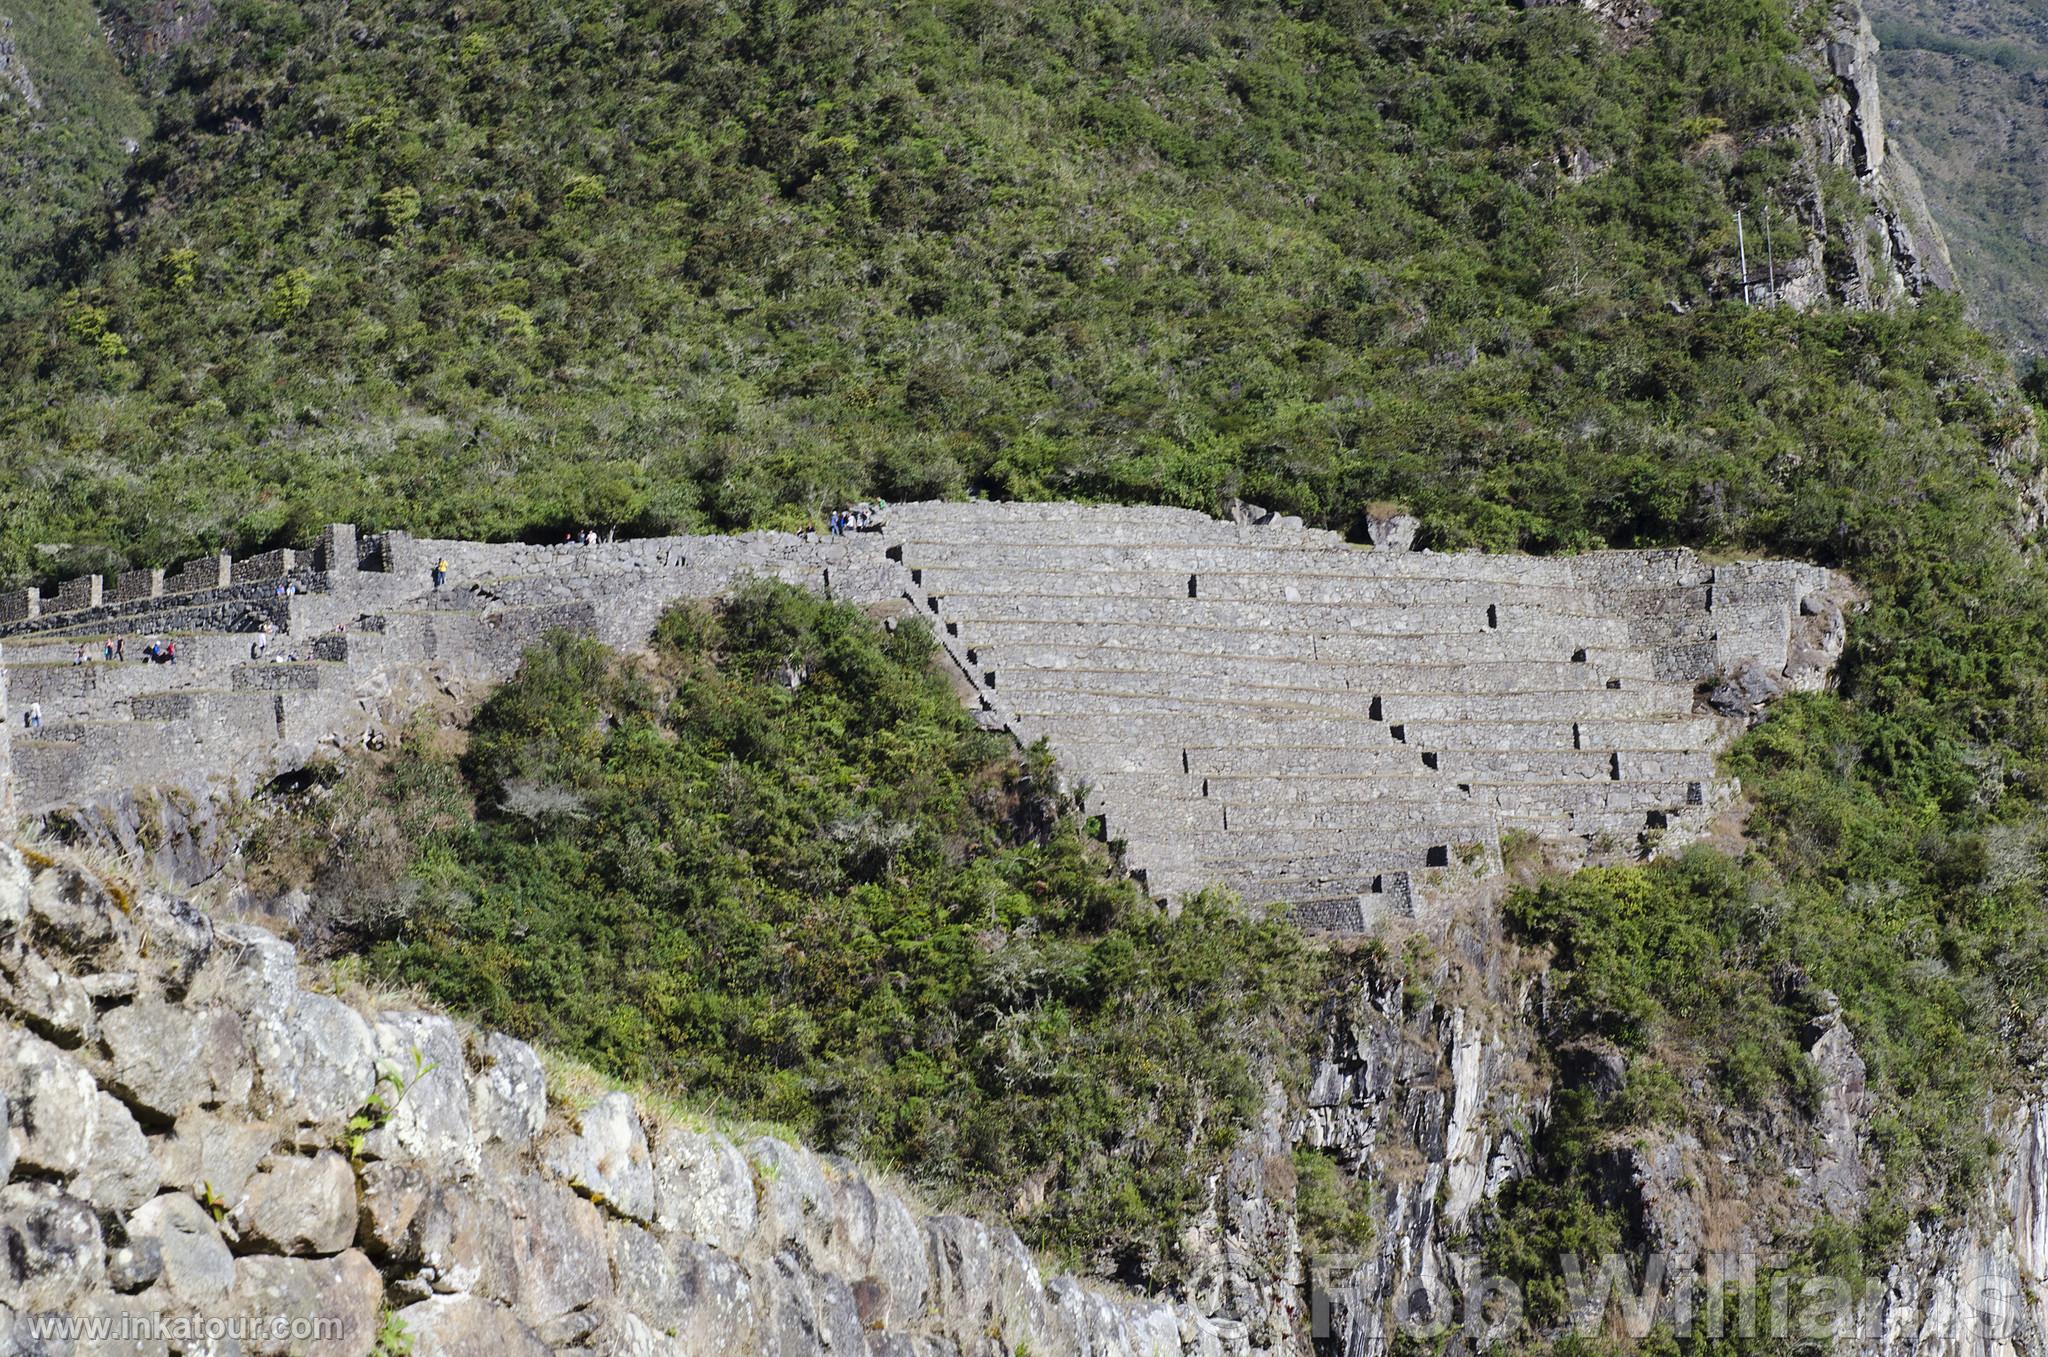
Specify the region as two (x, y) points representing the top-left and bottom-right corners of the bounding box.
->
(0, 845), (1243, 1357)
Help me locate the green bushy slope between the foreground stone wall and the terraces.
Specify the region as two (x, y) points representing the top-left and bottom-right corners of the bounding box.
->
(258, 583), (1317, 1279)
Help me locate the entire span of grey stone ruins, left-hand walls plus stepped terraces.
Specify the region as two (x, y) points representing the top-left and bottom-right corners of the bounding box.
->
(0, 504), (1841, 929)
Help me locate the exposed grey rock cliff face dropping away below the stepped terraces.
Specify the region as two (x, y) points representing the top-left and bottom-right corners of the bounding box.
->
(1196, 911), (2048, 1357)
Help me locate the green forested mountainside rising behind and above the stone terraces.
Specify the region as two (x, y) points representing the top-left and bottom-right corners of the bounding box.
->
(0, 0), (1949, 579)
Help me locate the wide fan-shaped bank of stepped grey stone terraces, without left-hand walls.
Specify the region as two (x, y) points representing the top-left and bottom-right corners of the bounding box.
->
(887, 504), (1839, 929)
